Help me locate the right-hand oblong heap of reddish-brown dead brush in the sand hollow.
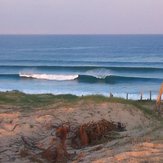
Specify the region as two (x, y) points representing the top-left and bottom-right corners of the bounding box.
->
(71, 119), (125, 148)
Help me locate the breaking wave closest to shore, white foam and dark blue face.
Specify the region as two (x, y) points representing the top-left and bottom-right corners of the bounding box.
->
(0, 73), (163, 84)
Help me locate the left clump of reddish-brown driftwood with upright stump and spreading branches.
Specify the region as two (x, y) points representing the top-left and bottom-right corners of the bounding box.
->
(20, 124), (70, 163)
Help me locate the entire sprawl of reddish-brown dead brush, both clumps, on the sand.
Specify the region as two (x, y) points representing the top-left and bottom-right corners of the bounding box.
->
(20, 119), (125, 163)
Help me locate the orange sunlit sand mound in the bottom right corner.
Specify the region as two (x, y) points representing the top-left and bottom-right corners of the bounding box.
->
(92, 142), (163, 163)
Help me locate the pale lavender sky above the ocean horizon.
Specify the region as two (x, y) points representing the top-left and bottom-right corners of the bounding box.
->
(0, 0), (163, 34)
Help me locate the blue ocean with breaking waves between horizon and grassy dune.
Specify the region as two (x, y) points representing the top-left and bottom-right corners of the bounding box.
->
(0, 35), (163, 99)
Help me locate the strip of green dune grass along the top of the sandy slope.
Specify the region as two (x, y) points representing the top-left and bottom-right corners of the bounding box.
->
(0, 91), (158, 117)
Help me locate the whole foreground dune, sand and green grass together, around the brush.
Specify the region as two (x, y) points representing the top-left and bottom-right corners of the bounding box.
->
(0, 91), (163, 163)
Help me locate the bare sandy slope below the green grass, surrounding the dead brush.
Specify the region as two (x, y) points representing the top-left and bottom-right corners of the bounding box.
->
(0, 101), (163, 163)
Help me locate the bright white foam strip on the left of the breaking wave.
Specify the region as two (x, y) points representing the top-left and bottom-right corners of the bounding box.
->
(19, 73), (78, 81)
